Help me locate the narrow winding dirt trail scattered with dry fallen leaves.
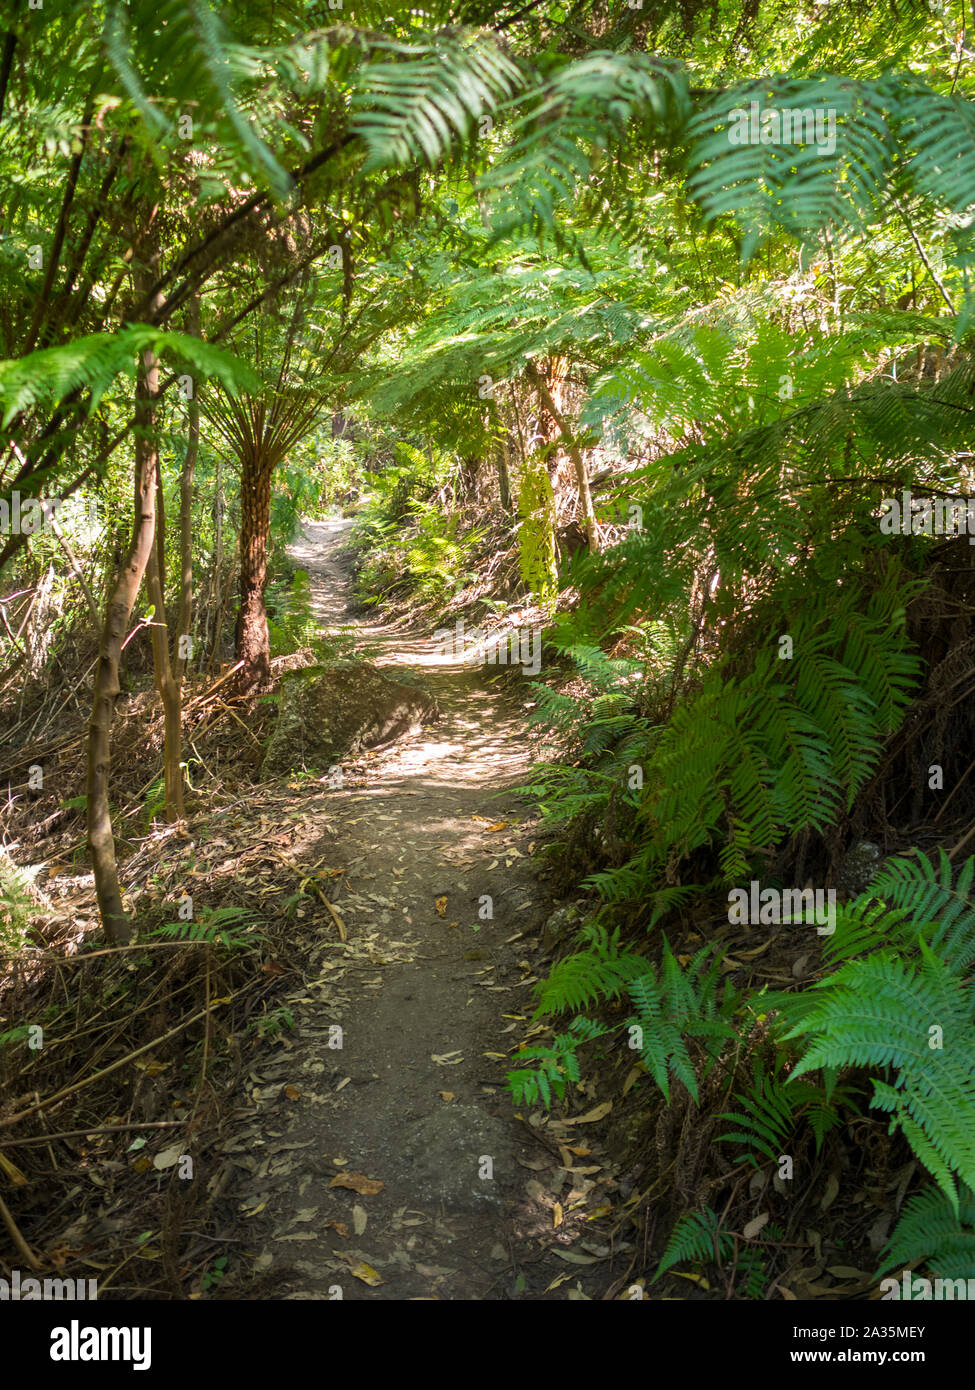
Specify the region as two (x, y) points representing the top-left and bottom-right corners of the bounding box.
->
(227, 521), (606, 1300)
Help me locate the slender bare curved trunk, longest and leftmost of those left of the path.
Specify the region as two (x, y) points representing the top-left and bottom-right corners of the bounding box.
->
(88, 332), (159, 945)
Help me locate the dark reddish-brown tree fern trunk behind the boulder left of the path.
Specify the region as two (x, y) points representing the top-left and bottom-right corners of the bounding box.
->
(236, 453), (274, 692)
